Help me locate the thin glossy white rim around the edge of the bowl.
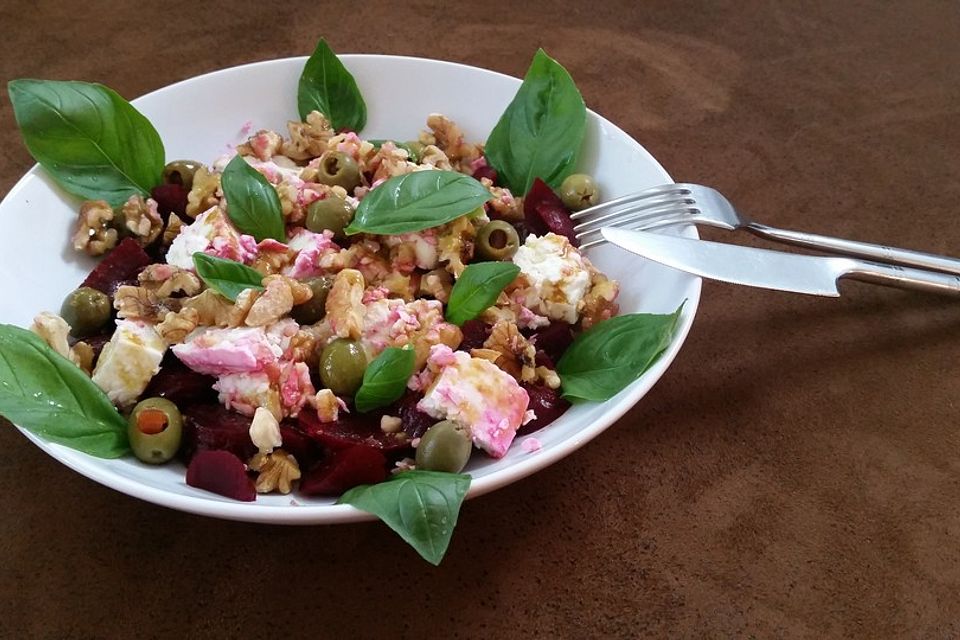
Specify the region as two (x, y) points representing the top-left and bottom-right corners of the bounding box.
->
(4, 53), (702, 525)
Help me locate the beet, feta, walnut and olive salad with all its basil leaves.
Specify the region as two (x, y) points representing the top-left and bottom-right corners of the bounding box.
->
(0, 41), (679, 562)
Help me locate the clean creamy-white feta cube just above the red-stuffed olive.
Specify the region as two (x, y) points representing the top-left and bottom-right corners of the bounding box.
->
(92, 320), (167, 407)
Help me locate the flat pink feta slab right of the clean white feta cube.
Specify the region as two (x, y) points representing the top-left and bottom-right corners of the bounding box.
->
(173, 327), (283, 376)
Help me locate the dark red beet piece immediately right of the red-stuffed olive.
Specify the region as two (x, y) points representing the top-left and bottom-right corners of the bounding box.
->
(180, 402), (257, 461)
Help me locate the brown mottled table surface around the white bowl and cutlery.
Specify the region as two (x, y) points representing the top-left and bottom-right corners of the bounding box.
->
(0, 0), (960, 638)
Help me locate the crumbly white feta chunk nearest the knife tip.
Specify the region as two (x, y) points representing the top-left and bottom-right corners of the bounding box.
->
(513, 233), (590, 324)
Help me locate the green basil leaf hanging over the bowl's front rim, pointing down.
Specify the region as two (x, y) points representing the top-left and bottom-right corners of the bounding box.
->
(337, 471), (470, 565)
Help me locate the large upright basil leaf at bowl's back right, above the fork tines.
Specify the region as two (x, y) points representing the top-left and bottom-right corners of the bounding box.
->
(485, 49), (587, 195)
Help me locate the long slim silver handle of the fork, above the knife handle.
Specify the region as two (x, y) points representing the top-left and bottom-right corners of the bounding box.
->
(746, 222), (960, 275)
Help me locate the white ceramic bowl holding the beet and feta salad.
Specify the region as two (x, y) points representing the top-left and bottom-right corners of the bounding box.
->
(0, 55), (700, 524)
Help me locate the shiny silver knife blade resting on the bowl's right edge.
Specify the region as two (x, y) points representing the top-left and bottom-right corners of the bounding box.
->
(600, 227), (855, 297)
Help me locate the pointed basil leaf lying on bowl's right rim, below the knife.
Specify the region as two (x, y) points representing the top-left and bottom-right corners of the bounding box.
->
(557, 304), (683, 402)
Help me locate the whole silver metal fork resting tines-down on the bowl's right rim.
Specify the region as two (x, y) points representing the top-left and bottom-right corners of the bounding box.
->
(571, 183), (960, 274)
